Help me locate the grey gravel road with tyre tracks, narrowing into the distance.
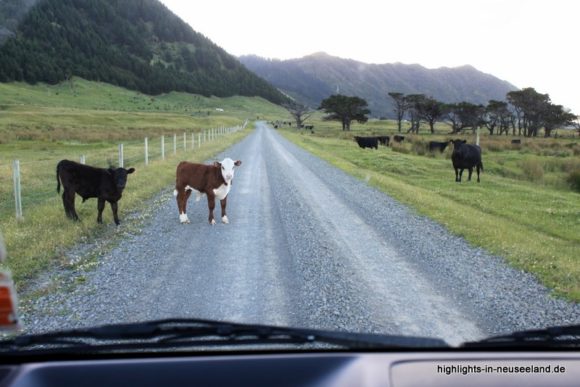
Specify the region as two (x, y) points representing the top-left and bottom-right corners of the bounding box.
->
(22, 124), (580, 344)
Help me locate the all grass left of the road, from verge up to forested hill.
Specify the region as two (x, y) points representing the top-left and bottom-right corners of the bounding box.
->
(0, 79), (285, 288)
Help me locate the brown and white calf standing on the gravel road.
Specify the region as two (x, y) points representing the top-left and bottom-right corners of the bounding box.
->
(173, 158), (242, 225)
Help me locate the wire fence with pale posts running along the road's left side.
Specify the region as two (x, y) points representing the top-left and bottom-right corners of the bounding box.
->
(0, 121), (247, 220)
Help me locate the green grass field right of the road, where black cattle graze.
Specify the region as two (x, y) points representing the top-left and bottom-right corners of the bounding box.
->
(282, 121), (580, 301)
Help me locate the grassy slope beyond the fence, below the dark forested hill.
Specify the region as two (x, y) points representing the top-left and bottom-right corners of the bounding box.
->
(0, 78), (285, 143)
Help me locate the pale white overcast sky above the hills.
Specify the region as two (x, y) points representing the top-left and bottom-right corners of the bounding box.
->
(161, 0), (580, 114)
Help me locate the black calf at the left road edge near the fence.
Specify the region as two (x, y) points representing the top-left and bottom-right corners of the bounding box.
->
(56, 160), (135, 226)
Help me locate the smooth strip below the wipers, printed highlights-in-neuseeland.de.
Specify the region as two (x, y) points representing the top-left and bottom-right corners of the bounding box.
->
(0, 351), (580, 387)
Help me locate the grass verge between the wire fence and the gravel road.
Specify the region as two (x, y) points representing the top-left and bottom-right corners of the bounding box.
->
(0, 129), (251, 286)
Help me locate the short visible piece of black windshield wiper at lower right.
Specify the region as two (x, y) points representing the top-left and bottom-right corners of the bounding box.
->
(461, 325), (580, 349)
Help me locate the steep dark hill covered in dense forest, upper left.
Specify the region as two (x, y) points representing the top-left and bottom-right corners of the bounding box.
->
(0, 0), (285, 103)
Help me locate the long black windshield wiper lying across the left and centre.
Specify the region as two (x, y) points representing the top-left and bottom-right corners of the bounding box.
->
(0, 319), (449, 354)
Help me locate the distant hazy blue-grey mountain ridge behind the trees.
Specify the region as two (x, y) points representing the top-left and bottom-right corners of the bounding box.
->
(240, 53), (517, 117)
